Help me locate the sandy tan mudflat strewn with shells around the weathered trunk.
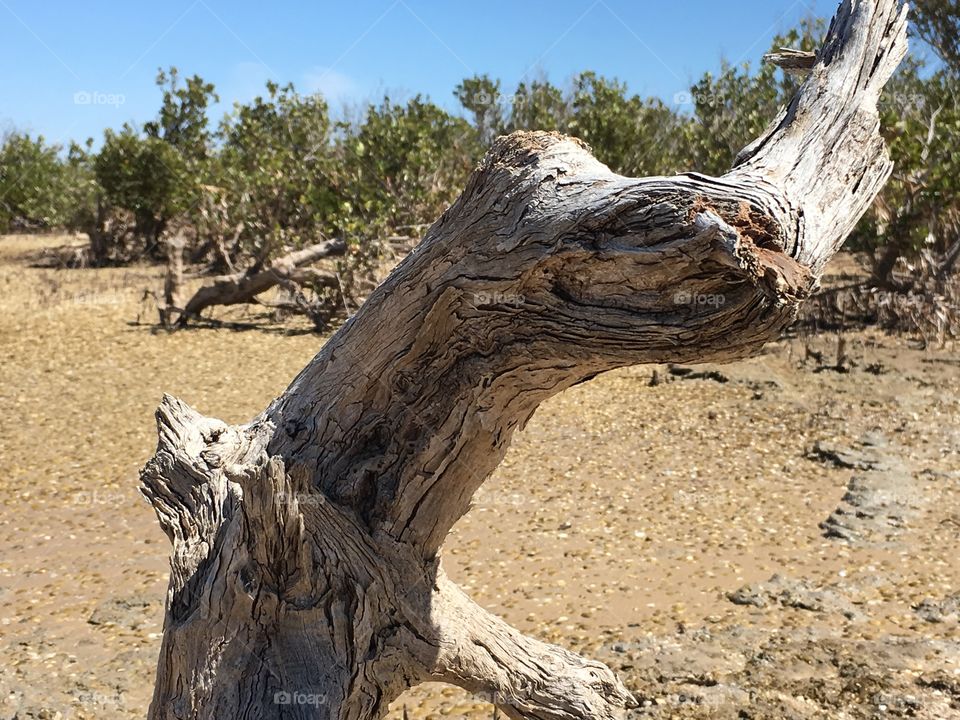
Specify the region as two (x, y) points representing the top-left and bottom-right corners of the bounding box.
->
(0, 237), (960, 720)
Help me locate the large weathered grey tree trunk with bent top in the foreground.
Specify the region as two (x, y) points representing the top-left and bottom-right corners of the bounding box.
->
(142, 0), (906, 720)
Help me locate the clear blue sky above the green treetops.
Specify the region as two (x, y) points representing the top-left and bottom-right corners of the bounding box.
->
(0, 0), (838, 143)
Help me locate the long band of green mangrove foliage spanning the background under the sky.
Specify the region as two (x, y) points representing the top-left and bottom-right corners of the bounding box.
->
(0, 15), (960, 298)
